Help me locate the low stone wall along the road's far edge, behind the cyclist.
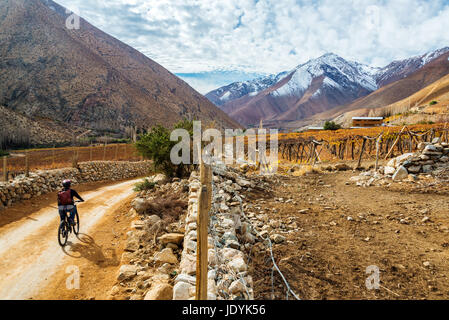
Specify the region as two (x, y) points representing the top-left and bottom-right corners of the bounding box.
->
(0, 161), (151, 209)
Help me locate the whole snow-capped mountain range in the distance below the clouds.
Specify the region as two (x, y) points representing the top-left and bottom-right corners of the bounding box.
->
(206, 48), (449, 125)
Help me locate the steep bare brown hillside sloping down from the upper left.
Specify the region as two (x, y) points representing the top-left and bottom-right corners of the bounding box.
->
(0, 0), (239, 141)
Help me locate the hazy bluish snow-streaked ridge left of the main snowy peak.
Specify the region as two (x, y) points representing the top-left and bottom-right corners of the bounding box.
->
(206, 72), (288, 106)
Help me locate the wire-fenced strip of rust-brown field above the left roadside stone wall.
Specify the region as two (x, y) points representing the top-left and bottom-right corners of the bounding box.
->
(0, 144), (142, 180)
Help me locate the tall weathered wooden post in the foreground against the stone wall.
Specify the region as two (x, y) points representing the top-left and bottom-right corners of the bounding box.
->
(196, 160), (212, 300)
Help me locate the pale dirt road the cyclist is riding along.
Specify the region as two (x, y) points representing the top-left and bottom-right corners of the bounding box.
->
(0, 180), (139, 299)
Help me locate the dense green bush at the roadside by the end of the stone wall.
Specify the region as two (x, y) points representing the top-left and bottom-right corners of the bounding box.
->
(136, 120), (193, 178)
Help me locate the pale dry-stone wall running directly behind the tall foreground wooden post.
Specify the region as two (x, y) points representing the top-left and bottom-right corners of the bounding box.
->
(173, 166), (255, 300)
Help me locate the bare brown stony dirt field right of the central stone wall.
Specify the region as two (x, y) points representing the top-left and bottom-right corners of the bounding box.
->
(249, 172), (449, 300)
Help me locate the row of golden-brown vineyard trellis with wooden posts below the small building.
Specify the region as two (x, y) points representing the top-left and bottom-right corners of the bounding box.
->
(272, 125), (449, 167)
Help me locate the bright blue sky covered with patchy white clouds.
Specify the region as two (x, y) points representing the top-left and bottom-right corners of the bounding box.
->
(56, 0), (449, 93)
